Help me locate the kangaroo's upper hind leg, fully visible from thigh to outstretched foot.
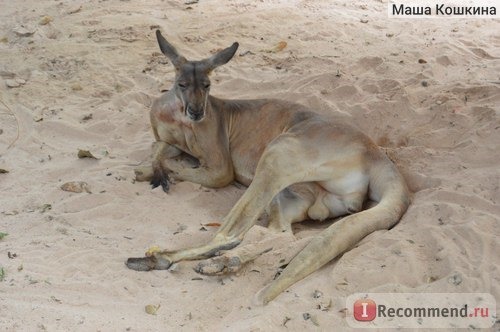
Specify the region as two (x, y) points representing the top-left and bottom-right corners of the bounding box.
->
(126, 135), (316, 270)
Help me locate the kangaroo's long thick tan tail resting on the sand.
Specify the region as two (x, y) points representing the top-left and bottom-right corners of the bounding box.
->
(257, 154), (410, 304)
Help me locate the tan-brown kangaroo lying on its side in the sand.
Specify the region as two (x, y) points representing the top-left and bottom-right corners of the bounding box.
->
(126, 30), (410, 304)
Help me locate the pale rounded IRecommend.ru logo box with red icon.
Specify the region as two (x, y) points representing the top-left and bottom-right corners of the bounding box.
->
(346, 293), (496, 328)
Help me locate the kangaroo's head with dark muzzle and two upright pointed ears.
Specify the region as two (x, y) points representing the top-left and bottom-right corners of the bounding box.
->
(156, 30), (238, 122)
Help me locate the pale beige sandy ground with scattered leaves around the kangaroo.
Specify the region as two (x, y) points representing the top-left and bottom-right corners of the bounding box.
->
(0, 0), (500, 331)
